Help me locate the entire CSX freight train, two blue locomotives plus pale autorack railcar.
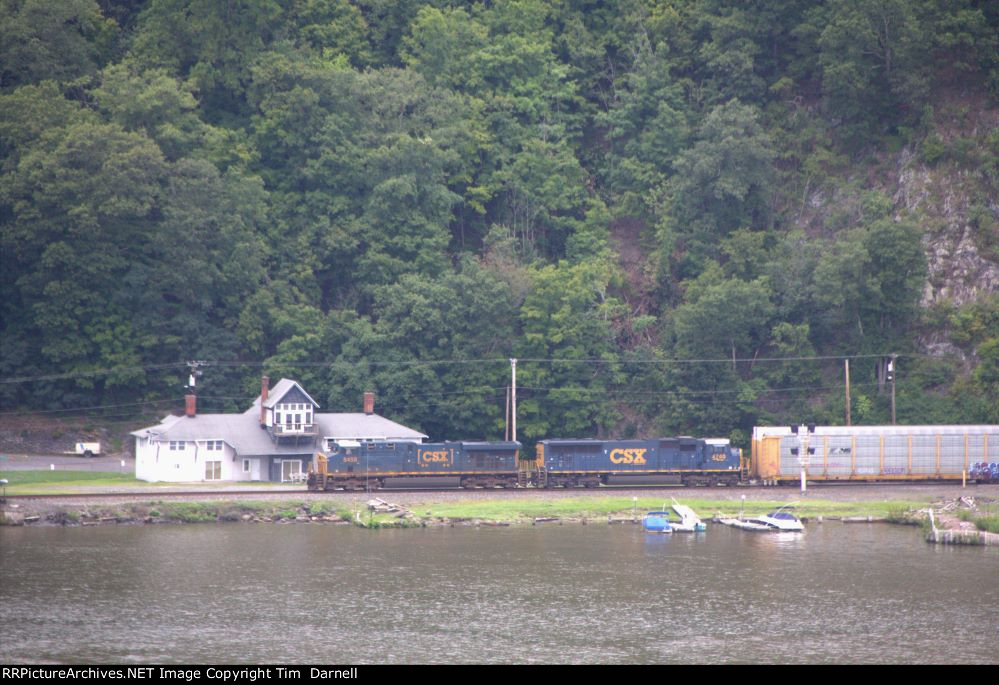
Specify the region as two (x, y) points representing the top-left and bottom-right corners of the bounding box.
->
(308, 425), (999, 490)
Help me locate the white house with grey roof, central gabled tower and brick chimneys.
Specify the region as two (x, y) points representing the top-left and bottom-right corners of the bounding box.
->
(131, 376), (427, 482)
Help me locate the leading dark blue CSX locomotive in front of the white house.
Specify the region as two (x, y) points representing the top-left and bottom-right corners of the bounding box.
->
(308, 440), (521, 490)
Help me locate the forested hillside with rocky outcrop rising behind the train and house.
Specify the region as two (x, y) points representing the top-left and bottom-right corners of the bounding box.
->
(0, 0), (999, 444)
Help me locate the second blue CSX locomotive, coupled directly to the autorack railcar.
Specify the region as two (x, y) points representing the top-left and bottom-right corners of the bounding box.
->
(534, 437), (742, 487)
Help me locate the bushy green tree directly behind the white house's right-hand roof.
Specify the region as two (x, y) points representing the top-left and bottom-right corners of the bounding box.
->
(329, 259), (516, 439)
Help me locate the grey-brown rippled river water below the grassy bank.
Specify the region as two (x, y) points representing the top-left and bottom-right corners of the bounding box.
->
(0, 523), (999, 664)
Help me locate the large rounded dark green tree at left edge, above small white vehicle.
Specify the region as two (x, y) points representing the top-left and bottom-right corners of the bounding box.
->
(0, 123), (166, 400)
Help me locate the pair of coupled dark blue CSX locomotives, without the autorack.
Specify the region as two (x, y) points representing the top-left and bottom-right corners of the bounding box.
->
(308, 438), (744, 490)
